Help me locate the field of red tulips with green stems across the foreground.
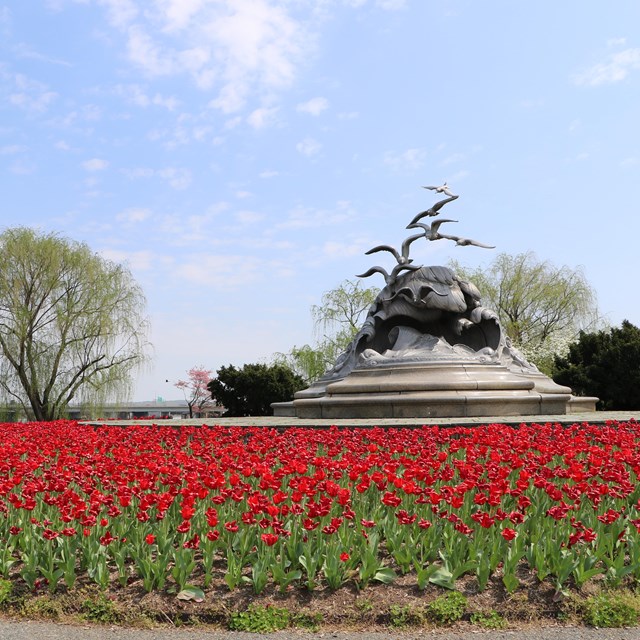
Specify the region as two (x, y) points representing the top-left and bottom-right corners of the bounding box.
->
(0, 421), (640, 594)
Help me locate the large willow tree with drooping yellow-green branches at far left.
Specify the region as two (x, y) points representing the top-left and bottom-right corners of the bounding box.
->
(0, 227), (148, 420)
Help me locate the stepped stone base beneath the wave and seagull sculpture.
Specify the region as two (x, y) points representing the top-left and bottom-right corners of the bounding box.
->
(282, 361), (571, 419)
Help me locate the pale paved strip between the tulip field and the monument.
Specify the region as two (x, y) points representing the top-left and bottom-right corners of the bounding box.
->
(84, 411), (640, 428)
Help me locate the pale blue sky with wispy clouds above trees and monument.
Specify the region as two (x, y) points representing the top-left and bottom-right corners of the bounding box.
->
(0, 0), (640, 400)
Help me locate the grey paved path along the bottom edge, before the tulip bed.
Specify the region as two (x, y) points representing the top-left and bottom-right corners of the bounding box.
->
(0, 620), (640, 640)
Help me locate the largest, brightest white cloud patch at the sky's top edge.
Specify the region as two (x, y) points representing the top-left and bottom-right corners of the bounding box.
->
(87, 0), (314, 113)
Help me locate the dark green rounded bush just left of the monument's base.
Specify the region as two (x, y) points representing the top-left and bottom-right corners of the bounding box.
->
(207, 364), (306, 416)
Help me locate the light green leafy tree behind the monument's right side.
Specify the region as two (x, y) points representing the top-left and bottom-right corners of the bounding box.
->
(449, 252), (598, 368)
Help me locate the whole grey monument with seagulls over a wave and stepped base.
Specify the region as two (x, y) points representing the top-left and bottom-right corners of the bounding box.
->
(274, 182), (594, 418)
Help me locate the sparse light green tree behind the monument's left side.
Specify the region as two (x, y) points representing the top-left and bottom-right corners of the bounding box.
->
(274, 280), (378, 384)
